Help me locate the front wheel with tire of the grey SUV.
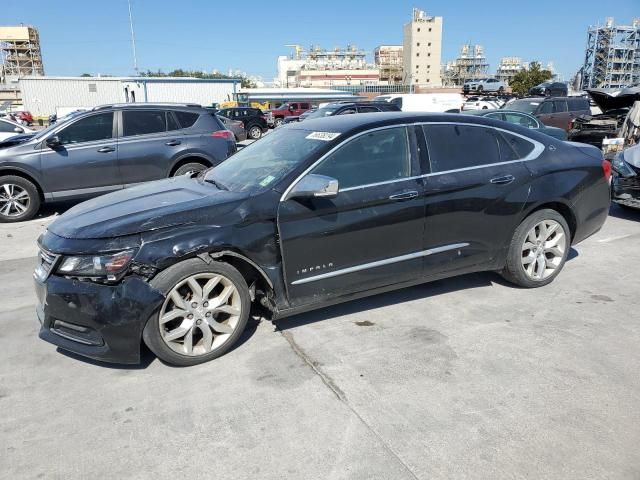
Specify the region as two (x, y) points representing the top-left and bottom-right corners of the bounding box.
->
(0, 175), (41, 223)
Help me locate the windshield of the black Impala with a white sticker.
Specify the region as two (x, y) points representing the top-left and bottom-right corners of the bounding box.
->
(204, 127), (335, 192)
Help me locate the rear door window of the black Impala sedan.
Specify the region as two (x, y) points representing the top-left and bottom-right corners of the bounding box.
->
(423, 124), (502, 173)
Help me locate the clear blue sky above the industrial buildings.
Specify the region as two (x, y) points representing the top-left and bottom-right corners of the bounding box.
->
(0, 0), (640, 81)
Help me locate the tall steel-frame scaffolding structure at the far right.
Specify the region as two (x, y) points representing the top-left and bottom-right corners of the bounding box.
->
(581, 17), (640, 89)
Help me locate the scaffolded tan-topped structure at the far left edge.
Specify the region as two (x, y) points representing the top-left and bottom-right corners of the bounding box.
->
(0, 26), (44, 82)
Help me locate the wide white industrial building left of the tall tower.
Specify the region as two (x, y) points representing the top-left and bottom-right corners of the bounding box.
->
(278, 45), (379, 88)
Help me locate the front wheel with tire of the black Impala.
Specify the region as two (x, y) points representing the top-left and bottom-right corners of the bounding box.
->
(142, 258), (251, 367)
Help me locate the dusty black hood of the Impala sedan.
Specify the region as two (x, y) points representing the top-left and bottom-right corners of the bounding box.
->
(49, 176), (248, 239)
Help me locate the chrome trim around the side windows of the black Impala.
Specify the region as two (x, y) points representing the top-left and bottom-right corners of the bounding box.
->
(280, 122), (546, 202)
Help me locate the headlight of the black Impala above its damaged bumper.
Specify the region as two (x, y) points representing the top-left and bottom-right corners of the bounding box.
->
(57, 250), (135, 281)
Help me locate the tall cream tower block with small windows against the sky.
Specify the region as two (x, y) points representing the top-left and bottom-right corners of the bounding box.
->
(403, 8), (442, 87)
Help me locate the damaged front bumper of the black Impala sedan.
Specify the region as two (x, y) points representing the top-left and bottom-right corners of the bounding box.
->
(34, 275), (164, 364)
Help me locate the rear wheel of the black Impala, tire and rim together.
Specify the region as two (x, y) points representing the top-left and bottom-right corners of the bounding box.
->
(502, 209), (571, 288)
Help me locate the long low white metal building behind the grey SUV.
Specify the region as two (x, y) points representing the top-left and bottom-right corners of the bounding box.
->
(19, 76), (240, 117)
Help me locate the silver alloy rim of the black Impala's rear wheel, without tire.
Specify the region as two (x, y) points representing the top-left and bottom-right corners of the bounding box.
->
(522, 220), (567, 280)
